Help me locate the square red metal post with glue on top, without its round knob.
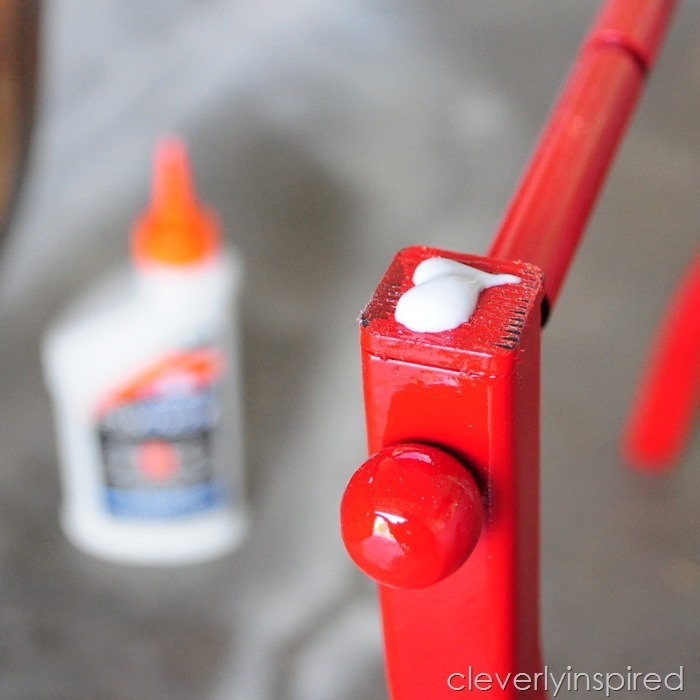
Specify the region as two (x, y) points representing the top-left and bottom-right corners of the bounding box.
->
(361, 248), (544, 700)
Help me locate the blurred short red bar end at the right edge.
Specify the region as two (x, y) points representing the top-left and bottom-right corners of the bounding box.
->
(622, 253), (700, 472)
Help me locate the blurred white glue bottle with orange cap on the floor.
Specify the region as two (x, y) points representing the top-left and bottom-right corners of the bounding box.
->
(42, 137), (247, 565)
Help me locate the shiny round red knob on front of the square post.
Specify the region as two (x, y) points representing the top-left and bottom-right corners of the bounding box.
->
(340, 444), (483, 588)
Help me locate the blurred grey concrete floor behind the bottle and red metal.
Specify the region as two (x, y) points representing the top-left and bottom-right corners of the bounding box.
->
(0, 0), (700, 700)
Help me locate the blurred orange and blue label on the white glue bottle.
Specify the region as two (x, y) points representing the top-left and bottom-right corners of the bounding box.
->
(97, 348), (224, 519)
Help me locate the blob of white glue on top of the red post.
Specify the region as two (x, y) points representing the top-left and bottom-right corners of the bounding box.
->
(394, 258), (520, 333)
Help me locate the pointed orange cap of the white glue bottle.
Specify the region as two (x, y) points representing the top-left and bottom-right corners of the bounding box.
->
(131, 136), (221, 265)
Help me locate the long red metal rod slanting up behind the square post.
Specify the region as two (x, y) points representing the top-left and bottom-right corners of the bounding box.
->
(487, 0), (675, 308)
